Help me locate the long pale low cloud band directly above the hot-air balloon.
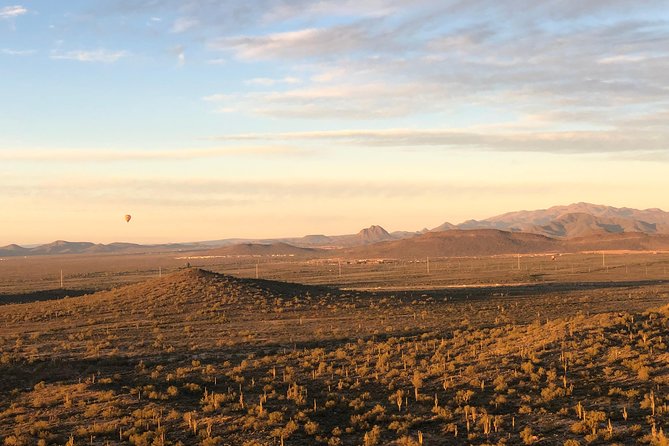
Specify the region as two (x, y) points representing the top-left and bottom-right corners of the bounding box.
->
(3, 176), (554, 207)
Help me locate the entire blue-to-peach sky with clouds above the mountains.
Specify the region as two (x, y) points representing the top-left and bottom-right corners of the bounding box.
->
(0, 0), (669, 245)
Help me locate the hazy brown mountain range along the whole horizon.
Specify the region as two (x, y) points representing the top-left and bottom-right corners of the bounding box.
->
(0, 203), (669, 257)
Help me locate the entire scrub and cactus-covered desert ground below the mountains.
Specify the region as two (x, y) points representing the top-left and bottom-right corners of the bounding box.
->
(0, 252), (669, 445)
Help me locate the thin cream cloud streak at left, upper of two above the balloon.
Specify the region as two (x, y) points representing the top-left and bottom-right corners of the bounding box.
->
(0, 144), (307, 163)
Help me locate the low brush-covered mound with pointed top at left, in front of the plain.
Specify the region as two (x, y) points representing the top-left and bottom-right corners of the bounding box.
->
(0, 268), (346, 357)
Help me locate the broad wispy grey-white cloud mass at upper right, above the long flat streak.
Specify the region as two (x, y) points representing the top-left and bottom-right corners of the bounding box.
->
(99, 0), (669, 128)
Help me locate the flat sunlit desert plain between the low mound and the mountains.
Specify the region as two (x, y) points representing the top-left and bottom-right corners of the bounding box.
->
(0, 251), (669, 294)
